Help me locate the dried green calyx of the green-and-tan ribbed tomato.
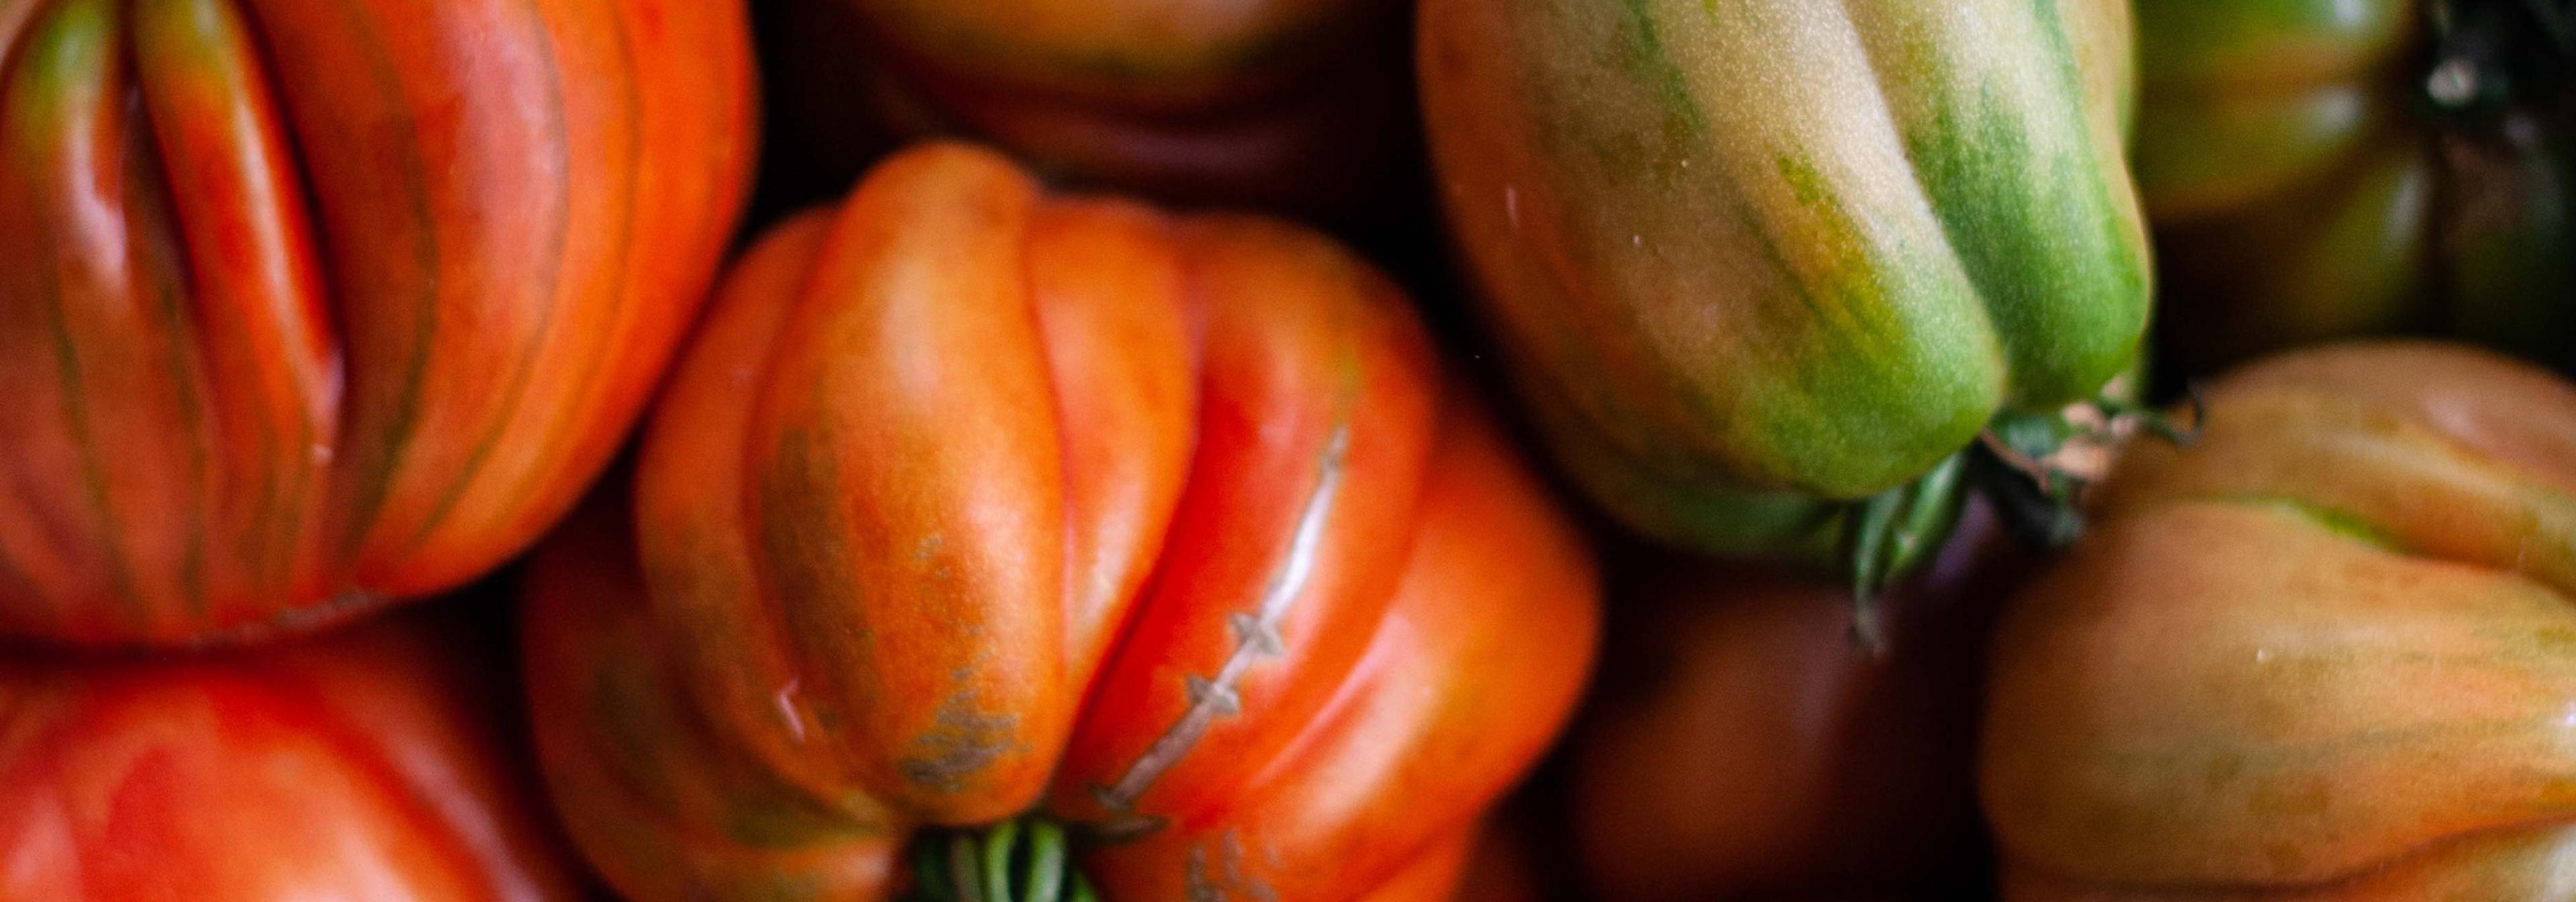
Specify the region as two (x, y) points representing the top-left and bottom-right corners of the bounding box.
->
(1842, 392), (2200, 654)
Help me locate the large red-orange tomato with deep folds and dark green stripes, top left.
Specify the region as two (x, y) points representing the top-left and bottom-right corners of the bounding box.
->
(0, 0), (752, 644)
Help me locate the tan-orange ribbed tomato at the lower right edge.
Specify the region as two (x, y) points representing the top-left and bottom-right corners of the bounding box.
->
(1981, 343), (2576, 902)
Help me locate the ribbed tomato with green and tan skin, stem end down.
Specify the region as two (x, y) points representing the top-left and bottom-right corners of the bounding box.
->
(1417, 0), (2149, 559)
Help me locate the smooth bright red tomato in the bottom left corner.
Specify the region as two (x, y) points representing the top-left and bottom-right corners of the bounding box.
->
(0, 616), (580, 902)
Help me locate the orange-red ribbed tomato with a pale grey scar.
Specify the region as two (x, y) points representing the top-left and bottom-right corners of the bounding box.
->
(525, 144), (1597, 899)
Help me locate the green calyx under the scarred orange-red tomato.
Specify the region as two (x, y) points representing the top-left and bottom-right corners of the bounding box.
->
(910, 814), (1100, 902)
